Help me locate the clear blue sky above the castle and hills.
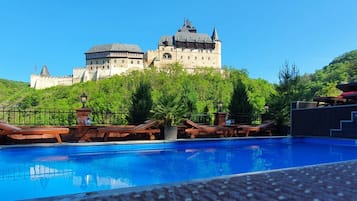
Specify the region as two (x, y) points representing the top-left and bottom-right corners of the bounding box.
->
(0, 0), (357, 82)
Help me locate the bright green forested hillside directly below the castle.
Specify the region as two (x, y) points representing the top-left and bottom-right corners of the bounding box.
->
(2, 64), (274, 123)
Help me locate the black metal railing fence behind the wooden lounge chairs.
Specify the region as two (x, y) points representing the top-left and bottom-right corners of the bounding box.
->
(0, 107), (259, 126)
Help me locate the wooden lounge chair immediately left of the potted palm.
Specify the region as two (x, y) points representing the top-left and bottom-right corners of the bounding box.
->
(98, 120), (160, 141)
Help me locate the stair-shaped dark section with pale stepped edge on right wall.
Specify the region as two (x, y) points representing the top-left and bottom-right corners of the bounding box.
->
(330, 111), (357, 138)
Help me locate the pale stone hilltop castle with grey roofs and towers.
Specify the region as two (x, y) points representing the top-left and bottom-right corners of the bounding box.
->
(30, 20), (221, 89)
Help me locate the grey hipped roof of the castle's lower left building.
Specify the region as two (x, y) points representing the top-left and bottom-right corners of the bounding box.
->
(86, 43), (143, 54)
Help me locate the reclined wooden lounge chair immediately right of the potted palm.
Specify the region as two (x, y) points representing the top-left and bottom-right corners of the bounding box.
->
(184, 120), (234, 138)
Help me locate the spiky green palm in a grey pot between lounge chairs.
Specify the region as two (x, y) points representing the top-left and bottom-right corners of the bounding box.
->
(151, 95), (187, 140)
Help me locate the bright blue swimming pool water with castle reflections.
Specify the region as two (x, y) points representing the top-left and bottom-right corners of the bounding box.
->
(0, 138), (357, 200)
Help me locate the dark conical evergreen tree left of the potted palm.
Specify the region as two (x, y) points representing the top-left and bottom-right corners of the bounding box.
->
(129, 82), (153, 124)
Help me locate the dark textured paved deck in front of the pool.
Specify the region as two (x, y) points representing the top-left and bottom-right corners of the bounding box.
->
(29, 160), (357, 201)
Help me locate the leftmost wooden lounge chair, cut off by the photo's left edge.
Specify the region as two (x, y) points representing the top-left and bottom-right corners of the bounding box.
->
(0, 121), (69, 143)
